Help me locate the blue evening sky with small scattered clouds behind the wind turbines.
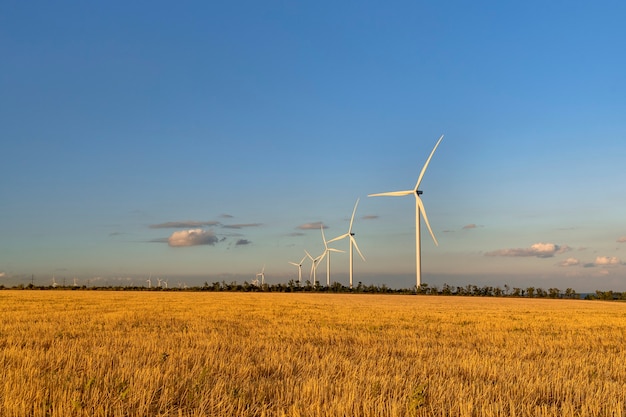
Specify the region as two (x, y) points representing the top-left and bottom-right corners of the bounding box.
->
(0, 0), (626, 292)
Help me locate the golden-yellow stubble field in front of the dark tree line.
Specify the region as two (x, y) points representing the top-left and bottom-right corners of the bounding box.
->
(0, 291), (626, 417)
